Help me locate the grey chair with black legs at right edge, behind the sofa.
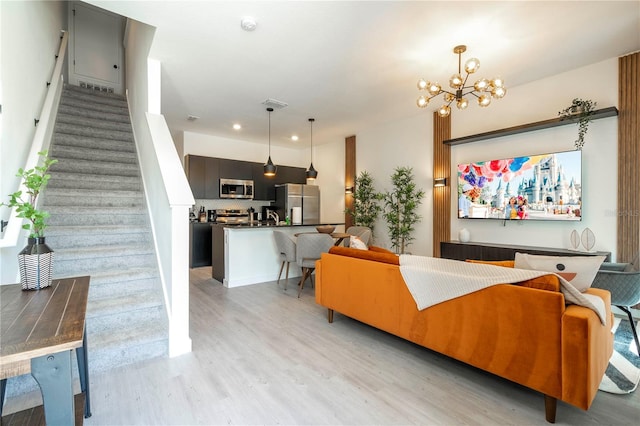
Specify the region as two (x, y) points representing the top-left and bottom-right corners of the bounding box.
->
(591, 262), (640, 354)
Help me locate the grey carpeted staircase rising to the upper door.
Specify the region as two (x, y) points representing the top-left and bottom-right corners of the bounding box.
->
(42, 85), (168, 374)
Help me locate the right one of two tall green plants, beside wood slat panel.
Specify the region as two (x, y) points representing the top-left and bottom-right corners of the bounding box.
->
(383, 167), (424, 254)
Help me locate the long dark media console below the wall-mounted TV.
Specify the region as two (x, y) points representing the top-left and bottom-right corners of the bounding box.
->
(440, 241), (611, 262)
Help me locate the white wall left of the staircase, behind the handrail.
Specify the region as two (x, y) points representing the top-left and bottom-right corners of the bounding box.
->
(0, 1), (67, 284)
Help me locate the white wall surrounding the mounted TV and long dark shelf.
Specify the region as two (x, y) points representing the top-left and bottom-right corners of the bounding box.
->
(451, 58), (618, 259)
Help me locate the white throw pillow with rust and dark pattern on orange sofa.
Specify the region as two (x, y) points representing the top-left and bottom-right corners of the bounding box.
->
(514, 253), (605, 292)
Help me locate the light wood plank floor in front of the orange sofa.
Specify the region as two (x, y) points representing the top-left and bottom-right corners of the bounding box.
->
(5, 268), (640, 425)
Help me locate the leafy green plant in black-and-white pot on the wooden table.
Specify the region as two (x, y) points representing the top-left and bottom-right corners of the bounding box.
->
(2, 151), (58, 290)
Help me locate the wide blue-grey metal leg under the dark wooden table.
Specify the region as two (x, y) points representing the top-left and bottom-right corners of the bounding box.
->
(31, 350), (75, 425)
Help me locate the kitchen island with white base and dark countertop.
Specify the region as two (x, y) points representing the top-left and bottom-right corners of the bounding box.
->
(211, 222), (344, 288)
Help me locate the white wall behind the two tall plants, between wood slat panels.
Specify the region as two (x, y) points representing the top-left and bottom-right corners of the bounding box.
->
(356, 108), (433, 256)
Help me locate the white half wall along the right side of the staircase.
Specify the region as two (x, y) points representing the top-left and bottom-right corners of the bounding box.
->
(125, 20), (194, 356)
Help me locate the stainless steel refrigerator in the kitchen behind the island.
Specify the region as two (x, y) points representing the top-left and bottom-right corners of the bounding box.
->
(273, 183), (320, 225)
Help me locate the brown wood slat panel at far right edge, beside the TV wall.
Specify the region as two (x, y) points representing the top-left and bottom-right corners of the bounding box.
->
(616, 53), (640, 262)
